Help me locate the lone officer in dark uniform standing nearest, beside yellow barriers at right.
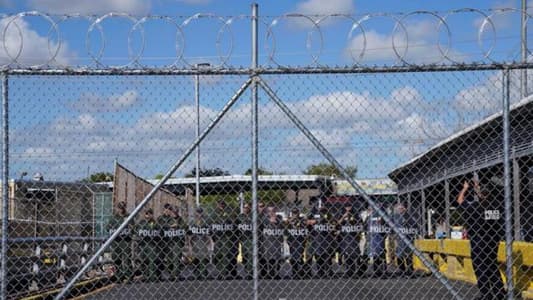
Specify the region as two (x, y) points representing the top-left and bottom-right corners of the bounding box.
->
(457, 178), (505, 299)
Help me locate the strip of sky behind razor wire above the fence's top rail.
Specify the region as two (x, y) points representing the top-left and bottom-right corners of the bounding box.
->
(0, 0), (531, 67)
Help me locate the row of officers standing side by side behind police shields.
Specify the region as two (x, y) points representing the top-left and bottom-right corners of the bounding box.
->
(107, 201), (414, 282)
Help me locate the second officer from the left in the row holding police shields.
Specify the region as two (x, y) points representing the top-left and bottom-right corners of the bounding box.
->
(137, 208), (161, 282)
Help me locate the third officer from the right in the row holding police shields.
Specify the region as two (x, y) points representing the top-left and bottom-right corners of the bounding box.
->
(338, 202), (366, 277)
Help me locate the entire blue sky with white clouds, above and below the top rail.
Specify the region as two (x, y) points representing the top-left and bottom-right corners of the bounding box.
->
(0, 0), (533, 181)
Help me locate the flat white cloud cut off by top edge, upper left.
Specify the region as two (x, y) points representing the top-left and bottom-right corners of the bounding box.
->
(28, 0), (151, 14)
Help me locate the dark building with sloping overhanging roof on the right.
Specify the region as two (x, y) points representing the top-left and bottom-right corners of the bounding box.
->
(389, 97), (533, 241)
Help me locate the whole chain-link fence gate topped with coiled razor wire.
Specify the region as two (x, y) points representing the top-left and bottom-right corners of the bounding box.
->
(1, 5), (533, 299)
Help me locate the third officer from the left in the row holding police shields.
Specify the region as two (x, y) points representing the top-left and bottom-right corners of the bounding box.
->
(158, 203), (187, 279)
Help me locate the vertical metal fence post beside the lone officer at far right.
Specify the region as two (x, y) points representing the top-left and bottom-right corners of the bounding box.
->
(502, 69), (514, 299)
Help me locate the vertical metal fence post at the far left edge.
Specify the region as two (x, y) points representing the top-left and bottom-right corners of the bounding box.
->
(0, 73), (9, 299)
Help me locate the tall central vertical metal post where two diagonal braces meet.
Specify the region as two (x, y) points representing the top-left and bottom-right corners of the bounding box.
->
(251, 3), (259, 300)
